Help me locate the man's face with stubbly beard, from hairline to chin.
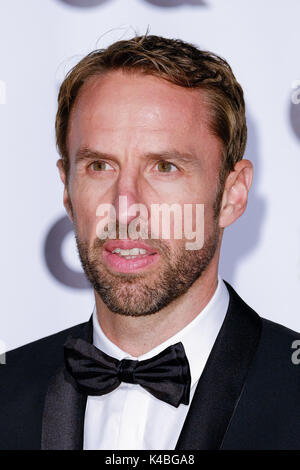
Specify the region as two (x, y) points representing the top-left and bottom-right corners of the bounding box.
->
(65, 71), (222, 316)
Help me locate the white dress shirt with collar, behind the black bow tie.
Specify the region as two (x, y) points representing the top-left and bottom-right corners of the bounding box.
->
(83, 277), (229, 450)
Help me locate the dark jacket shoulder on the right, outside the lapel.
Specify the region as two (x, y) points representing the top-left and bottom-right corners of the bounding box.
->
(224, 288), (300, 450)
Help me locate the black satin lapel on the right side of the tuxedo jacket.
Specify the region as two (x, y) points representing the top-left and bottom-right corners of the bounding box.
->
(176, 283), (261, 450)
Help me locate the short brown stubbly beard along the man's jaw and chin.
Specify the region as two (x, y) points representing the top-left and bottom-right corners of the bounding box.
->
(75, 218), (220, 317)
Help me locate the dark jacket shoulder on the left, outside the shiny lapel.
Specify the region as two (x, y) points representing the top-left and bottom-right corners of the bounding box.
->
(0, 322), (89, 449)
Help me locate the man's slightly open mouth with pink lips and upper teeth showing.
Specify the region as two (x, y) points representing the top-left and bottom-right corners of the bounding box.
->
(103, 240), (159, 273)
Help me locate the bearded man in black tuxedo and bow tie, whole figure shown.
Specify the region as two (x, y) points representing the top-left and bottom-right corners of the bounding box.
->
(0, 35), (300, 450)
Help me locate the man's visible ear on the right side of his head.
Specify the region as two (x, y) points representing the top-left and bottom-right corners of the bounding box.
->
(219, 160), (253, 228)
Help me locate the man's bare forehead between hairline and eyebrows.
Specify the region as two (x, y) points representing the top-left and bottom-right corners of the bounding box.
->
(68, 71), (216, 155)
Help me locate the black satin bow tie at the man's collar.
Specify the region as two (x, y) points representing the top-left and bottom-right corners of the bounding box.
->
(64, 338), (191, 408)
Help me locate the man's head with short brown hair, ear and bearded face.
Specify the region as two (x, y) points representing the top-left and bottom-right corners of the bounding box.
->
(56, 36), (252, 316)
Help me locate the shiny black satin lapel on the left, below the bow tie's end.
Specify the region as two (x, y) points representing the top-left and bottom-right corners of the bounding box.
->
(41, 320), (92, 450)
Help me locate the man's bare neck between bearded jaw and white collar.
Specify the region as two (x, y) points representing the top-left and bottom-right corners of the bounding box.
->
(95, 262), (218, 357)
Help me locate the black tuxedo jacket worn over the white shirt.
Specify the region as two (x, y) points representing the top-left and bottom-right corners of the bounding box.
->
(0, 283), (300, 450)
